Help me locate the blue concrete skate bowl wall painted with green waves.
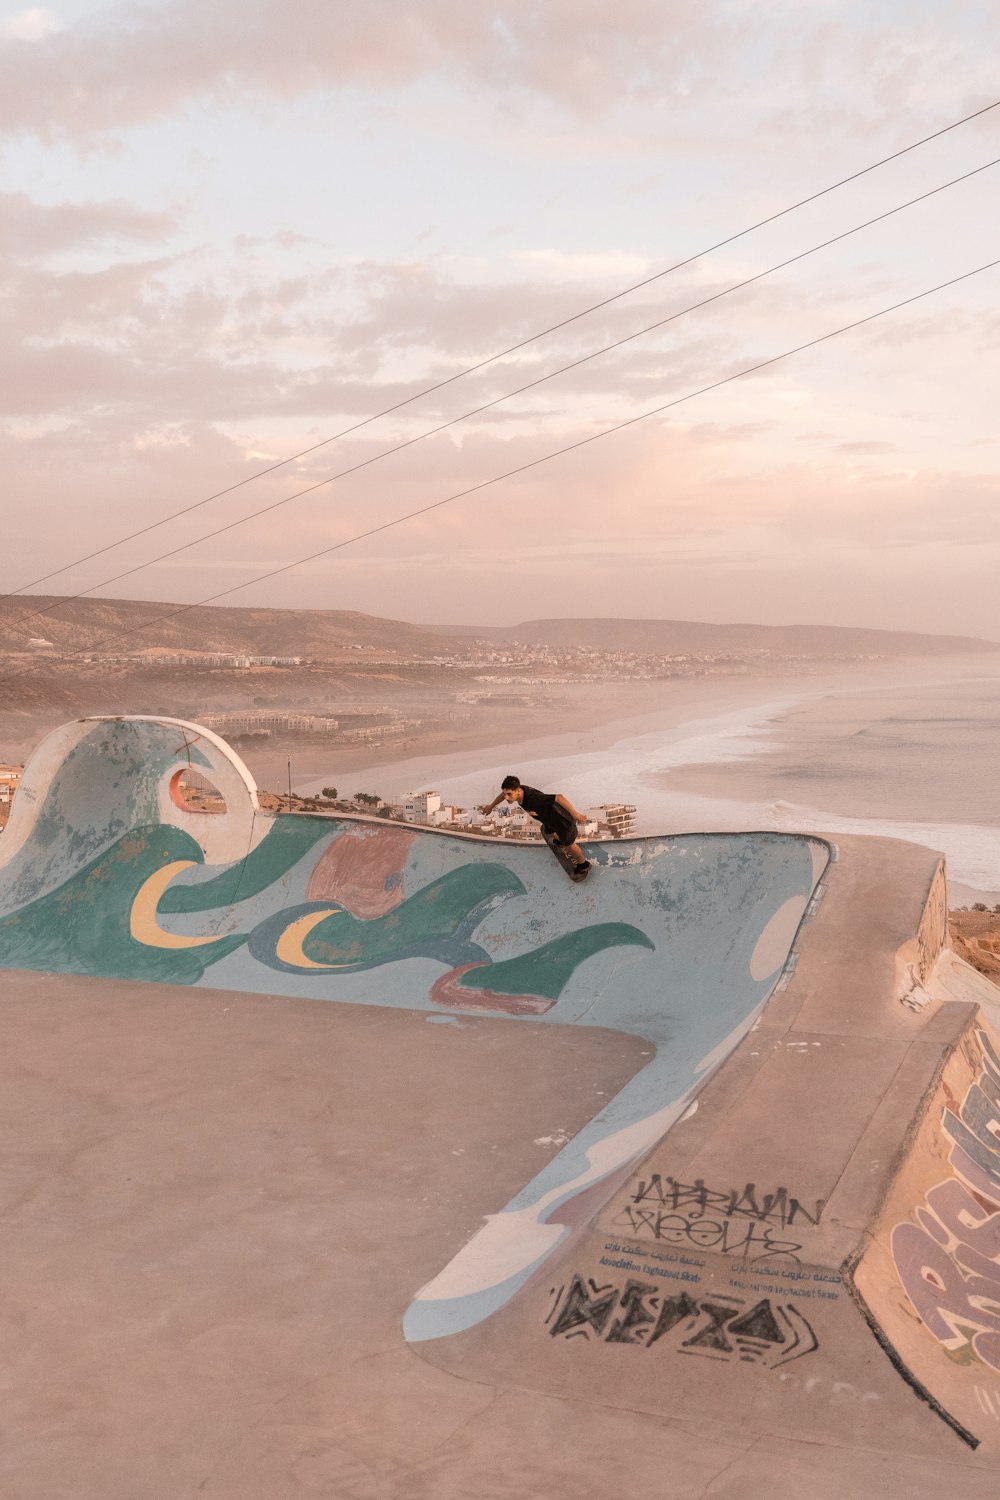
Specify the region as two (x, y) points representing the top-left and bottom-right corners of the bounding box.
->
(0, 719), (829, 1343)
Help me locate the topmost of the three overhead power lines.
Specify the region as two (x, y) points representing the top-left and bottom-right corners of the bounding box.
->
(0, 99), (1000, 603)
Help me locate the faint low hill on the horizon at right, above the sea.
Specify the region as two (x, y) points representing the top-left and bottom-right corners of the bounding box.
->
(436, 620), (1000, 657)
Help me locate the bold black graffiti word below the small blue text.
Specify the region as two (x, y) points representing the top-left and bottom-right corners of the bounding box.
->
(546, 1275), (819, 1370)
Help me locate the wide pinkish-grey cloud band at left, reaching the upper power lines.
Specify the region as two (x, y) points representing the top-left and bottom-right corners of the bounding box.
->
(0, 219), (749, 426)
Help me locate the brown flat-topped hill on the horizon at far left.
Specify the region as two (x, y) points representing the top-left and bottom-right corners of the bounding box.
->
(0, 594), (456, 659)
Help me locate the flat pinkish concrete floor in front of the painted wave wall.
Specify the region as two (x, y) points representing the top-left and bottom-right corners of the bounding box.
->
(7, 972), (1000, 1500)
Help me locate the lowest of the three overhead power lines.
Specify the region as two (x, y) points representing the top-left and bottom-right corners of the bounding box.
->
(10, 258), (1000, 678)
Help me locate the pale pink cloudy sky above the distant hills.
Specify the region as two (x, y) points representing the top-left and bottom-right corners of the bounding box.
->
(0, 0), (1000, 639)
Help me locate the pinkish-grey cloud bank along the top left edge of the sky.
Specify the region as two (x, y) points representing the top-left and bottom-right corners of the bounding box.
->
(0, 0), (735, 138)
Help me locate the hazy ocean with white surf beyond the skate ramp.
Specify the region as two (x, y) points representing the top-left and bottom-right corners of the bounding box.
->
(302, 657), (1000, 905)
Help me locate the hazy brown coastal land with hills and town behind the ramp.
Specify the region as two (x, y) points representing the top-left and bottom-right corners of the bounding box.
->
(0, 599), (991, 839)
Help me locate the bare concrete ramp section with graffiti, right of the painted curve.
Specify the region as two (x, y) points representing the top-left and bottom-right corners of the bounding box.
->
(421, 840), (1000, 1476)
